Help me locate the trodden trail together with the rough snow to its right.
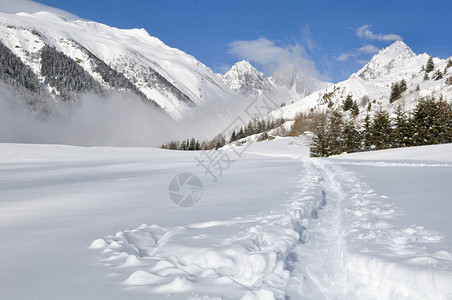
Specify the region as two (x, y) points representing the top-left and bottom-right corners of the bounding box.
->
(288, 160), (452, 299)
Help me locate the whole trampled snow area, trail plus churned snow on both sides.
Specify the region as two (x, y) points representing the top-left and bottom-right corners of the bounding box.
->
(90, 158), (452, 299)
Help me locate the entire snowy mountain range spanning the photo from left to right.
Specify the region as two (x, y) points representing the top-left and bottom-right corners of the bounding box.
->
(0, 12), (452, 125)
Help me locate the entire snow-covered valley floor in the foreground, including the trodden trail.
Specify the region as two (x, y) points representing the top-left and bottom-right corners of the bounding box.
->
(0, 138), (452, 299)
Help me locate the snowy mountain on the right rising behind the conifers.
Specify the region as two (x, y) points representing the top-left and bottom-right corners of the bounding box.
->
(274, 41), (452, 118)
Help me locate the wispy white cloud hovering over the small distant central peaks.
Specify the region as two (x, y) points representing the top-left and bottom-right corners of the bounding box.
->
(228, 38), (318, 77)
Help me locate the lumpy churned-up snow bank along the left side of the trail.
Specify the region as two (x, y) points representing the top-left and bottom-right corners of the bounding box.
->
(91, 160), (326, 299)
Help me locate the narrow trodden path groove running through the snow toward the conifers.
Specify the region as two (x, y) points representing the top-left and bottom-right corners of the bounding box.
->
(287, 160), (347, 299)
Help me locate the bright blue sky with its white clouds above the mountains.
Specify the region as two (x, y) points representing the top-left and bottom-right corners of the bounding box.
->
(32, 0), (452, 82)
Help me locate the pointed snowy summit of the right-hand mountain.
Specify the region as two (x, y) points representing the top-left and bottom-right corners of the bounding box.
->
(351, 40), (416, 80)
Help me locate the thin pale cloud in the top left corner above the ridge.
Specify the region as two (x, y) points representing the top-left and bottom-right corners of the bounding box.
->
(0, 0), (80, 20)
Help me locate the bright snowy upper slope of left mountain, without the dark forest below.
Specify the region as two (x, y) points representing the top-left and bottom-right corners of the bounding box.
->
(0, 12), (234, 119)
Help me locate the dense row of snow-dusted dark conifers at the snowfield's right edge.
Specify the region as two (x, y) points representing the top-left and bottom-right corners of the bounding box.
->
(310, 97), (452, 157)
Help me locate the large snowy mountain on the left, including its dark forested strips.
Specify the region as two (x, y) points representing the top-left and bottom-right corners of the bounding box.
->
(0, 12), (234, 119)
